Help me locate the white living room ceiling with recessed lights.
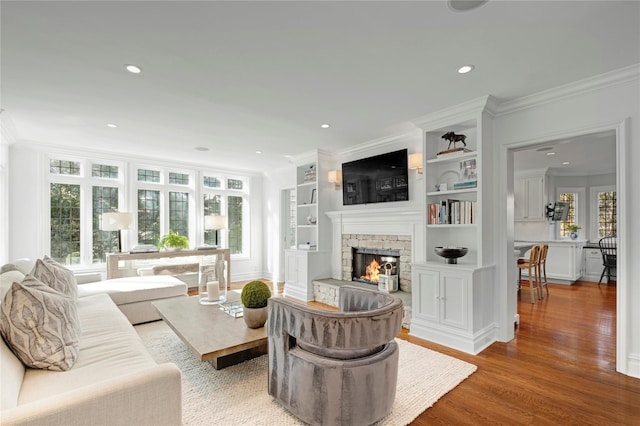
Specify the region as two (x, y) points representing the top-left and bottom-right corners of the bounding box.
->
(0, 0), (640, 171)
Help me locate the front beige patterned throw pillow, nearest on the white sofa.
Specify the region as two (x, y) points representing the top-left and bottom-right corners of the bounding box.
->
(0, 275), (81, 371)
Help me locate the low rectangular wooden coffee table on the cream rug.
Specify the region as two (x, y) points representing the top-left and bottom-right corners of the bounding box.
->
(152, 293), (267, 370)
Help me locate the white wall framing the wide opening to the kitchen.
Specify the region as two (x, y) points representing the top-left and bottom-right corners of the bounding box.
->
(494, 66), (640, 377)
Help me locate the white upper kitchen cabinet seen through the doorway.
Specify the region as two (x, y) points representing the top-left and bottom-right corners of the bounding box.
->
(513, 170), (547, 221)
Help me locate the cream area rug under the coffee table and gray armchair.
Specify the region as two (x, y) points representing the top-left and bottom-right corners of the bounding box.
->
(136, 321), (477, 426)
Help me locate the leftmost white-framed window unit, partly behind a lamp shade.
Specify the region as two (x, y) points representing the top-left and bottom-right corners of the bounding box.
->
(47, 158), (123, 265)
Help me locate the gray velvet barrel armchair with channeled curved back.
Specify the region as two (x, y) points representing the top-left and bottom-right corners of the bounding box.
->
(267, 286), (402, 425)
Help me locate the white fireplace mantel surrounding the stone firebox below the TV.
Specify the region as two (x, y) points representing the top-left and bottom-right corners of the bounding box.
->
(326, 208), (424, 279)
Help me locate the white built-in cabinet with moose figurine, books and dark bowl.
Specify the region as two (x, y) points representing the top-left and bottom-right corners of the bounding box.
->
(410, 97), (496, 354)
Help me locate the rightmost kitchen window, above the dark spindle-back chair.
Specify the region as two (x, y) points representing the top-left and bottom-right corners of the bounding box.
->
(590, 185), (618, 240)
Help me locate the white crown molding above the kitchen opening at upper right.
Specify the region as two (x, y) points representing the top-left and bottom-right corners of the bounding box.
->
(495, 64), (640, 115)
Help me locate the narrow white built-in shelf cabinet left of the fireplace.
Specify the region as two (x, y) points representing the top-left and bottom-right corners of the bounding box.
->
(284, 151), (332, 301)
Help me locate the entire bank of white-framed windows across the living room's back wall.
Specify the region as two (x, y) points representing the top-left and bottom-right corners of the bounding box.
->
(43, 154), (250, 266)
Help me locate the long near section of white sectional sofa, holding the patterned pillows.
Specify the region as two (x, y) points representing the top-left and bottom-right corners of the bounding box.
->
(0, 262), (186, 426)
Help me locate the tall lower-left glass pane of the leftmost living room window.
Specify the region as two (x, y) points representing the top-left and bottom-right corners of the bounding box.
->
(50, 183), (80, 265)
